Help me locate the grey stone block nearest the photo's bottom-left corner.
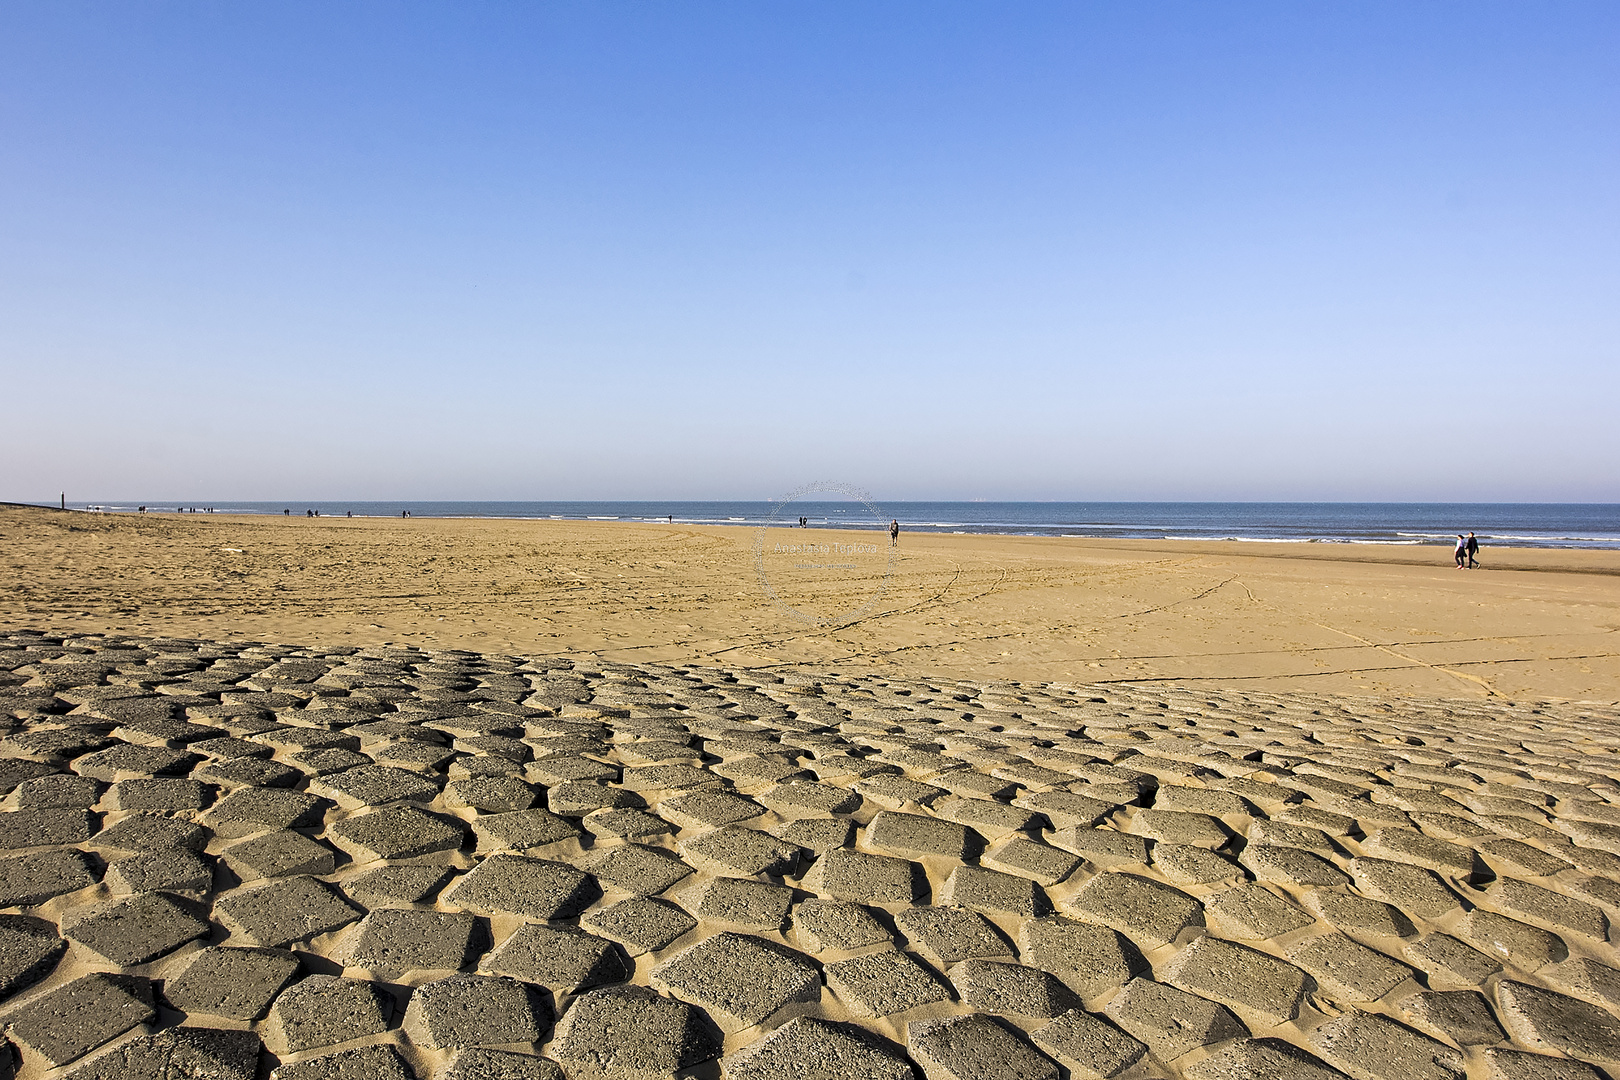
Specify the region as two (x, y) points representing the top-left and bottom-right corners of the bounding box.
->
(5, 973), (157, 1067)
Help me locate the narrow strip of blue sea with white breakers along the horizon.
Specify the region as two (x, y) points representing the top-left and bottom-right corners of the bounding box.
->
(66, 500), (1620, 549)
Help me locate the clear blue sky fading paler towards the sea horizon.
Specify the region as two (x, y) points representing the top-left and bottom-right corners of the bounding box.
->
(0, 0), (1620, 502)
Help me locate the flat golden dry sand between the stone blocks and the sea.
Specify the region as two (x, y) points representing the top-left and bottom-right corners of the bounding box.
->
(0, 507), (1620, 703)
